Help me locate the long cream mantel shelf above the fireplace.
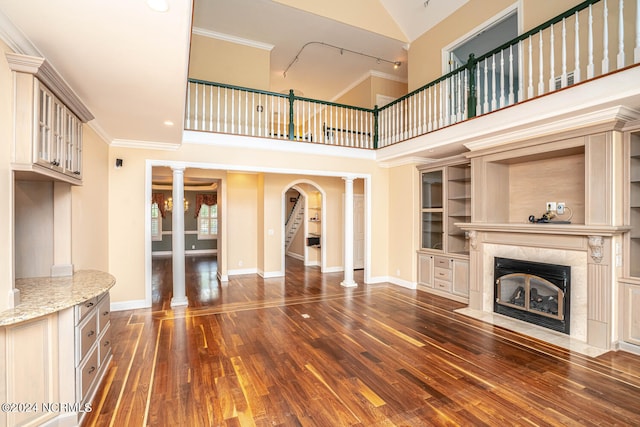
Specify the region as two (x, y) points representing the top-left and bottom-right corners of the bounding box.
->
(456, 222), (631, 237)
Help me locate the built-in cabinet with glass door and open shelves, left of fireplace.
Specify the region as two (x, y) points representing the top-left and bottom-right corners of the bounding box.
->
(418, 158), (471, 302)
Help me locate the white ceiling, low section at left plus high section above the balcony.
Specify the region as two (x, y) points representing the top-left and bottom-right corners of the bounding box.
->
(0, 0), (468, 146)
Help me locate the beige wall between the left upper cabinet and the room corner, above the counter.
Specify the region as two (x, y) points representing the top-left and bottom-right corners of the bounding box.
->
(71, 125), (113, 271)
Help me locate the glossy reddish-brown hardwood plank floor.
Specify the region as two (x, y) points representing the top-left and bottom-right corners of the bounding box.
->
(83, 258), (640, 426)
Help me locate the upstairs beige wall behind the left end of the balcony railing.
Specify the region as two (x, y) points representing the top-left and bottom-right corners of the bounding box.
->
(189, 34), (271, 90)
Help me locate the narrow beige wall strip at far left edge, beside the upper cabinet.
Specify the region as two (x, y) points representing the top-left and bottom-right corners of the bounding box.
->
(0, 42), (13, 310)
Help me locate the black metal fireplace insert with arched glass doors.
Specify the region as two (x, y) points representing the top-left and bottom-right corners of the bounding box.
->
(493, 257), (571, 334)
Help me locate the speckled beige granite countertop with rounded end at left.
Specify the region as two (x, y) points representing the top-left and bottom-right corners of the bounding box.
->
(0, 270), (116, 326)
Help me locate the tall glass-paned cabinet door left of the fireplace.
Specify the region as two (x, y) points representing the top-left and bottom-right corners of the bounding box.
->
(421, 170), (444, 250)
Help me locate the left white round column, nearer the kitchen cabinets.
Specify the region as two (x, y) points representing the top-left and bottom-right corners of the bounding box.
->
(171, 167), (188, 307)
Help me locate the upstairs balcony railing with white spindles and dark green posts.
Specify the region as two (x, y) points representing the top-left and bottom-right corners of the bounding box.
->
(185, 0), (640, 157)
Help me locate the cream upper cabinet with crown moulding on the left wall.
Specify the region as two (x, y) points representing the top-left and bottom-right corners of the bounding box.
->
(6, 53), (93, 185)
